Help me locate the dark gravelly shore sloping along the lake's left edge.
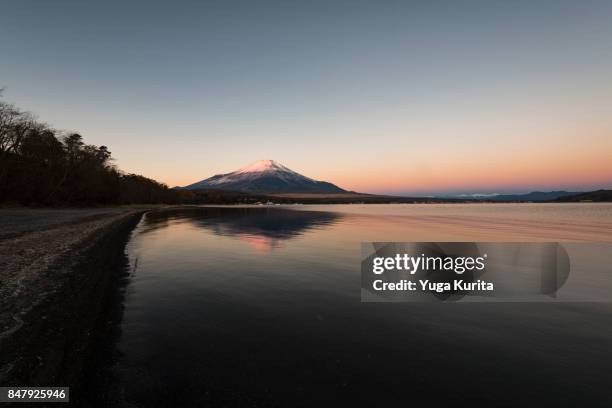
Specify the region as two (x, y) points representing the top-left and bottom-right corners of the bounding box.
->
(0, 208), (147, 396)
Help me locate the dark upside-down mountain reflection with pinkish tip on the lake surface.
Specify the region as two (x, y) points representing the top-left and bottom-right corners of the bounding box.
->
(143, 207), (341, 251)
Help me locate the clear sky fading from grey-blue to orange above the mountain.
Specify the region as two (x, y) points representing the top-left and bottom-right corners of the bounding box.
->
(0, 0), (612, 195)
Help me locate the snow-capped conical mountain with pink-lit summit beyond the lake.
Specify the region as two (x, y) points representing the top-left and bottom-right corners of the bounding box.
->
(183, 160), (346, 193)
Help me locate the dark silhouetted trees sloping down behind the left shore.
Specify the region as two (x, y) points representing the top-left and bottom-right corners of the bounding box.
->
(0, 95), (181, 205)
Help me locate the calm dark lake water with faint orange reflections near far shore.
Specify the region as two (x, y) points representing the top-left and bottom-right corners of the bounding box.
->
(88, 204), (612, 407)
